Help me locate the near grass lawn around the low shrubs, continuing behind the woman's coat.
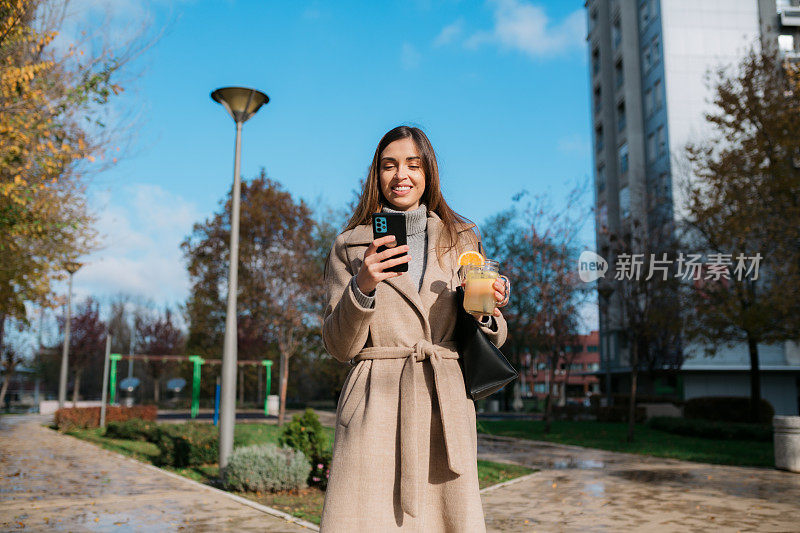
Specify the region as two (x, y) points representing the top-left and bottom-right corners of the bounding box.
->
(69, 424), (533, 524)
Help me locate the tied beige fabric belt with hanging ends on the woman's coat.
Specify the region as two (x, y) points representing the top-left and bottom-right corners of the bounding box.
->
(352, 340), (471, 517)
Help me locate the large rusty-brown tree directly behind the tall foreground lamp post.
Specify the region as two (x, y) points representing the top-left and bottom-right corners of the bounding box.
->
(181, 169), (321, 424)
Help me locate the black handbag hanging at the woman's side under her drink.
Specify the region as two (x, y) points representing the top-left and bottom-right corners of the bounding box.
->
(455, 287), (519, 400)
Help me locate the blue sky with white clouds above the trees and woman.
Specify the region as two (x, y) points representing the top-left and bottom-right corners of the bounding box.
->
(62, 0), (594, 326)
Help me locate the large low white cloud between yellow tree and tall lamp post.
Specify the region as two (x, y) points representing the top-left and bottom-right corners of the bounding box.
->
(75, 185), (200, 304)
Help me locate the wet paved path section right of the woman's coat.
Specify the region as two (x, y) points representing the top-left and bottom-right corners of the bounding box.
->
(478, 435), (800, 532)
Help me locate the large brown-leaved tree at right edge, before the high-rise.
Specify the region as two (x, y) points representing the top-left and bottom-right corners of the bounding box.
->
(685, 44), (800, 421)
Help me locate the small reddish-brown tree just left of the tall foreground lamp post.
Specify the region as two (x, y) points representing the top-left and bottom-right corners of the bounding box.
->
(136, 308), (185, 404)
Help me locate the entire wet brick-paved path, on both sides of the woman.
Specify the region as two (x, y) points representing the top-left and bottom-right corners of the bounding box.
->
(0, 412), (800, 532)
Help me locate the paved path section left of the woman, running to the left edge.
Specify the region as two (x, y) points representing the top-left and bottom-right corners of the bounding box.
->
(0, 416), (310, 532)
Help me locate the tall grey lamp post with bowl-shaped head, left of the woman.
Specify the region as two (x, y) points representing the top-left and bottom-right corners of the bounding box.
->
(211, 87), (269, 468)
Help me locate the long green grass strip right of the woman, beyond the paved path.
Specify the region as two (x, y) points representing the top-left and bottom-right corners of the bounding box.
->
(478, 420), (775, 467)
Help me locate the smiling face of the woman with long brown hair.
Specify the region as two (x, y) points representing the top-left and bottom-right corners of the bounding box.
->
(378, 138), (425, 211)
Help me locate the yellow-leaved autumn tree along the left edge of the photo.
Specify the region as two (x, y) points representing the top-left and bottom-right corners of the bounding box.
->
(0, 0), (150, 354)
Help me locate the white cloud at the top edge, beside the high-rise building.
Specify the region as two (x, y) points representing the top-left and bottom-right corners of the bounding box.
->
(464, 0), (585, 58)
